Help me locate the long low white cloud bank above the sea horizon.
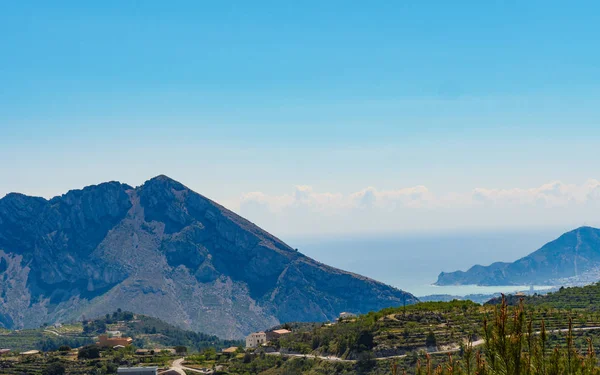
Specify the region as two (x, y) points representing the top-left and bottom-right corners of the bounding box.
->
(232, 180), (600, 234)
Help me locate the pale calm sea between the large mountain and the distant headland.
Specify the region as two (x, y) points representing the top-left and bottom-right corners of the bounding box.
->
(284, 230), (563, 296)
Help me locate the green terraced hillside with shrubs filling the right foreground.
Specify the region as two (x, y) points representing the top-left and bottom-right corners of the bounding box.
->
(203, 290), (600, 375)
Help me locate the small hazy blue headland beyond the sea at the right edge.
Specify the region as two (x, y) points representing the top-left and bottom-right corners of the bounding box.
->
(436, 227), (600, 285)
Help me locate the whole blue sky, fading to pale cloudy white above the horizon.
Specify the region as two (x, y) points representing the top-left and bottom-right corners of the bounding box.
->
(0, 1), (600, 233)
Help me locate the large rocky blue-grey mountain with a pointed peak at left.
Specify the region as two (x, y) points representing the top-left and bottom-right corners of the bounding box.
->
(0, 176), (416, 338)
